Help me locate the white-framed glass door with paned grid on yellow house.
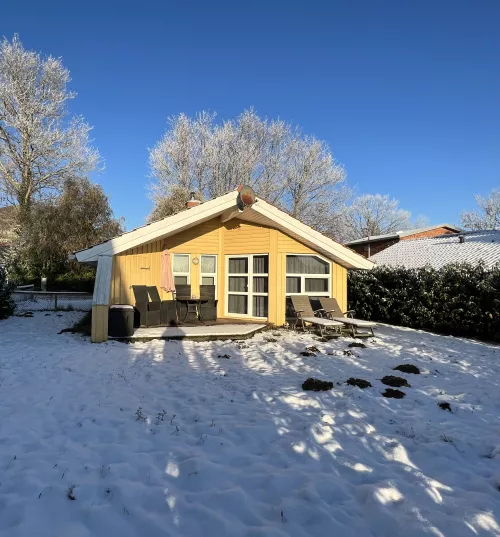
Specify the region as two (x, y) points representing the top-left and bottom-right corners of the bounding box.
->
(226, 254), (269, 319)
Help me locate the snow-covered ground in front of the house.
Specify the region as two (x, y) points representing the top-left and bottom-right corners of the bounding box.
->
(0, 313), (500, 537)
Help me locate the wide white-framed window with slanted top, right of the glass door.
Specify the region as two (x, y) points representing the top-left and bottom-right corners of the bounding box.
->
(286, 255), (331, 296)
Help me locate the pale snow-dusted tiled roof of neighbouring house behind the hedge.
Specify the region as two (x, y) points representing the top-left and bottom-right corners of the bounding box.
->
(370, 230), (500, 268)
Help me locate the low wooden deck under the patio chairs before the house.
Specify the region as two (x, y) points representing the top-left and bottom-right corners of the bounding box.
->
(109, 322), (266, 341)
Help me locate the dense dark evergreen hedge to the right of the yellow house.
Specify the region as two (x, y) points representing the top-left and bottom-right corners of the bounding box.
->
(348, 263), (500, 341)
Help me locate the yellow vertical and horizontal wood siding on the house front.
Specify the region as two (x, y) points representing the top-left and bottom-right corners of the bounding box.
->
(111, 218), (347, 325)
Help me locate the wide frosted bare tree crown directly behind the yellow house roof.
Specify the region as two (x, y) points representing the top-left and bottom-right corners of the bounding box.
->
(149, 110), (349, 234)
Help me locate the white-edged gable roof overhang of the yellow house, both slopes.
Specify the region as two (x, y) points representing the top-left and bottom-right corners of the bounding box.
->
(75, 190), (374, 269)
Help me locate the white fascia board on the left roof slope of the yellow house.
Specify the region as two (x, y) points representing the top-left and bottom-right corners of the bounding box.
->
(75, 191), (238, 263)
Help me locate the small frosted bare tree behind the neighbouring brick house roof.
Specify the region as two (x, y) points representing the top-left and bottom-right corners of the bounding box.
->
(344, 194), (412, 240)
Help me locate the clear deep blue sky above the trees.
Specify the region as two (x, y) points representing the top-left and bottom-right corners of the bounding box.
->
(0, 0), (500, 228)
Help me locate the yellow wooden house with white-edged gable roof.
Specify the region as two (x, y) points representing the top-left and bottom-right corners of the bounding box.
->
(75, 187), (373, 342)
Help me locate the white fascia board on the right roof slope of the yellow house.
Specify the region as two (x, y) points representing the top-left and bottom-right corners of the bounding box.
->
(252, 200), (375, 269)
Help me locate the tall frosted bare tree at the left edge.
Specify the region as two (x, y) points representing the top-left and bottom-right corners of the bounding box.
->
(0, 35), (100, 209)
